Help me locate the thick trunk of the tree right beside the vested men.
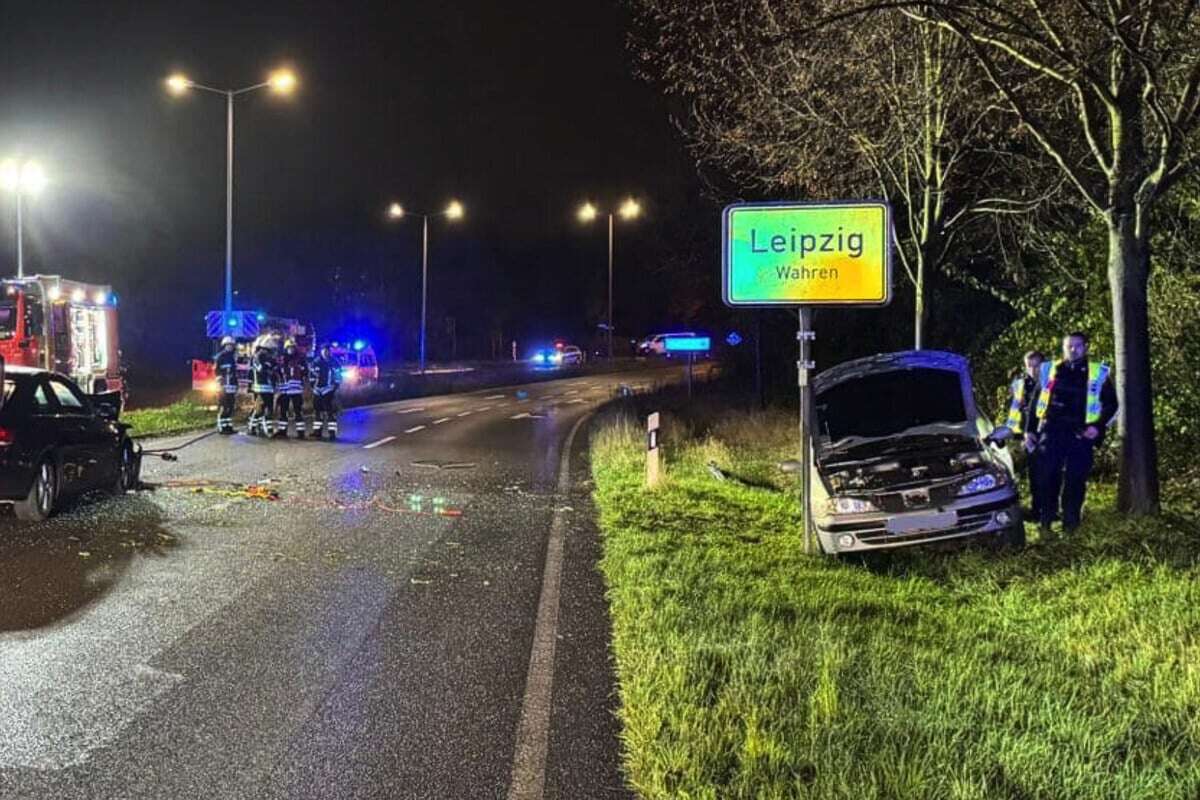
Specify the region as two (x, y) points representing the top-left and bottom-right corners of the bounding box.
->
(1105, 211), (1158, 515)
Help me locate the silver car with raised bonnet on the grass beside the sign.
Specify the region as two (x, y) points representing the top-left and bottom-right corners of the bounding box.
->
(811, 350), (1025, 553)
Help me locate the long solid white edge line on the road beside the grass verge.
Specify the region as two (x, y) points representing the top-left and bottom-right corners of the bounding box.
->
(508, 414), (592, 800)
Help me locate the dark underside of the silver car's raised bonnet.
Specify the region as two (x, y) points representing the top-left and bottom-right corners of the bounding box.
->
(815, 368), (967, 445)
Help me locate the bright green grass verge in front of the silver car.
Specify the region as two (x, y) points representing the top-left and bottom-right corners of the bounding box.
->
(593, 415), (1200, 800)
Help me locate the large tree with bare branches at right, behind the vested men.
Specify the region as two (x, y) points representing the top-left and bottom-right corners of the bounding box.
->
(864, 0), (1200, 513)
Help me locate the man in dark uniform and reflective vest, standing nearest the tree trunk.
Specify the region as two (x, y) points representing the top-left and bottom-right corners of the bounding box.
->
(1025, 331), (1117, 534)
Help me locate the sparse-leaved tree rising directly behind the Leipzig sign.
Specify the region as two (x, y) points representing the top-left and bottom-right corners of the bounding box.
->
(632, 0), (1038, 348)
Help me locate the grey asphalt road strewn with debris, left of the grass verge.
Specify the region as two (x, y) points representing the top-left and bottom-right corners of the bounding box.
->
(0, 369), (677, 800)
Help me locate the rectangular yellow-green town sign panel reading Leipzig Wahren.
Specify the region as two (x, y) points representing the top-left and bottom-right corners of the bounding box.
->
(722, 201), (892, 306)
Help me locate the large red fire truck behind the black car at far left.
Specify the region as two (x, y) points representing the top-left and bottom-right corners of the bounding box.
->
(0, 275), (125, 395)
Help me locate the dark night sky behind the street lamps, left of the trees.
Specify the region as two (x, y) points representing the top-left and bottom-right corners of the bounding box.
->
(0, 0), (705, 369)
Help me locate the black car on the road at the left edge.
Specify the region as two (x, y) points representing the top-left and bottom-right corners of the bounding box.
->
(0, 367), (142, 522)
